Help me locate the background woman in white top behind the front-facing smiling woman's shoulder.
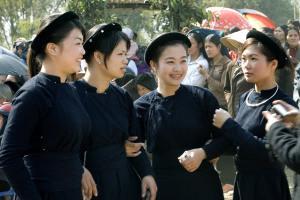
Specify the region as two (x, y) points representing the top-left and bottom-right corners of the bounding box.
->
(182, 32), (208, 87)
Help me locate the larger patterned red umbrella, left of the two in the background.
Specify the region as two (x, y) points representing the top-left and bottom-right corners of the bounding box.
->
(206, 7), (252, 30)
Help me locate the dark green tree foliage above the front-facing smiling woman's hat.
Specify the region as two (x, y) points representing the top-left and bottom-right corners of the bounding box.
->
(149, 0), (205, 31)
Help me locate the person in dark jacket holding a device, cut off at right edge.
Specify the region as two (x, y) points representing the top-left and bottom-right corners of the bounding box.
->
(263, 100), (300, 200)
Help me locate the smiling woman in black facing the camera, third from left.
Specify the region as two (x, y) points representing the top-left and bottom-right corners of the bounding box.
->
(135, 32), (228, 200)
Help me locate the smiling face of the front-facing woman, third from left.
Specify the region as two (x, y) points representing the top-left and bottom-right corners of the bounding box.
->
(150, 44), (188, 87)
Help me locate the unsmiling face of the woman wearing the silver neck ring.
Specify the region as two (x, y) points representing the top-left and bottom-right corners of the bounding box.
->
(241, 44), (277, 84)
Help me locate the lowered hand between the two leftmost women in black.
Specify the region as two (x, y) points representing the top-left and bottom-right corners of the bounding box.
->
(81, 167), (98, 200)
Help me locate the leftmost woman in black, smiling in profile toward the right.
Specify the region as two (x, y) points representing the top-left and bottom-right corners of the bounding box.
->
(0, 12), (94, 200)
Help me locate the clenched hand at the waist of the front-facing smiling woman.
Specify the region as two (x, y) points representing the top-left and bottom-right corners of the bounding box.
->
(178, 148), (206, 172)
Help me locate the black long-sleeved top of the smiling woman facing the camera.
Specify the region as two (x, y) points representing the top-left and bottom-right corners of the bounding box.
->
(135, 85), (229, 164)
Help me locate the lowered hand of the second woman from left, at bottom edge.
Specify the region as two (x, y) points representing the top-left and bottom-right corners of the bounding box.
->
(142, 176), (157, 200)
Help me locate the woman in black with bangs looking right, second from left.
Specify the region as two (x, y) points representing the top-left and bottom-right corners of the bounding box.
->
(74, 23), (156, 200)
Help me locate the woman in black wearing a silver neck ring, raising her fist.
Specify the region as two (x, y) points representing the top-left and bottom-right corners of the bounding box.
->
(214, 30), (295, 200)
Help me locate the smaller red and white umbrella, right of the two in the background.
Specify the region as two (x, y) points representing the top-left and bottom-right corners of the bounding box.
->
(238, 9), (276, 29)
